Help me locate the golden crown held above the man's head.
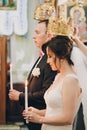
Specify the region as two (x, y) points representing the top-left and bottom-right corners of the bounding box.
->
(34, 0), (55, 21)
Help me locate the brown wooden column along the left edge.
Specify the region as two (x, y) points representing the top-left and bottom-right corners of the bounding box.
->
(0, 37), (7, 124)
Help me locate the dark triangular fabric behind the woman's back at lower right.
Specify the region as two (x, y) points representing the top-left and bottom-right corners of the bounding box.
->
(74, 103), (86, 130)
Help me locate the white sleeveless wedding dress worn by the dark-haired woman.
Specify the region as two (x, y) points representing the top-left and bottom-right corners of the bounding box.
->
(41, 74), (82, 130)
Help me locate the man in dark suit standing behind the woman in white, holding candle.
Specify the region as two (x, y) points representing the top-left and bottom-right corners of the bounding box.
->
(9, 20), (57, 130)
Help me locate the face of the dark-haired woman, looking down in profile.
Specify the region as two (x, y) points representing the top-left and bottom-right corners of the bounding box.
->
(46, 47), (57, 71)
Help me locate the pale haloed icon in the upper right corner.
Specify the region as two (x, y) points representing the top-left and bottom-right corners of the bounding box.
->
(70, 6), (87, 37)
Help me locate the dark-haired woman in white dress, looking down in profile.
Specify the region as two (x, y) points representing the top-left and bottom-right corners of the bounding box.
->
(23, 36), (82, 130)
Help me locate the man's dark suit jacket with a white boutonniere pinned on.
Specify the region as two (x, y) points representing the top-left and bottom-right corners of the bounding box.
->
(19, 45), (57, 130)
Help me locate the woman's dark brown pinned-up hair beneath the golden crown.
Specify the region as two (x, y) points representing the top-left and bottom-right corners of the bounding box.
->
(47, 35), (73, 65)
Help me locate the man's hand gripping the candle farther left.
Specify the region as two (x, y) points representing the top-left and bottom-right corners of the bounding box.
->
(8, 89), (21, 101)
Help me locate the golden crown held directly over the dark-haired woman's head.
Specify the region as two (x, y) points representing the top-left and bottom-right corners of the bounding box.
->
(48, 16), (74, 36)
